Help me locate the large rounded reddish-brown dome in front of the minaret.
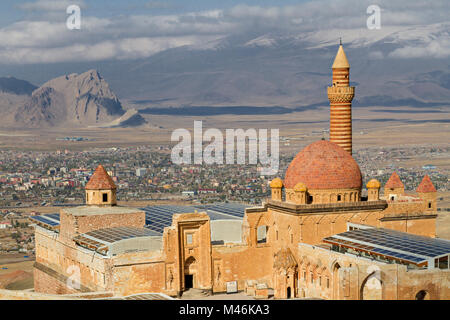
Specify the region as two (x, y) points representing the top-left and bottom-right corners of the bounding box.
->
(284, 140), (362, 190)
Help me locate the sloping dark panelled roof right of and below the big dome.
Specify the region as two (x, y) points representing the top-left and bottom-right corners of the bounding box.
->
(324, 228), (450, 264)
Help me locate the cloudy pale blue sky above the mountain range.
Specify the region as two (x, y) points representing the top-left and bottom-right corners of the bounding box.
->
(0, 0), (450, 65)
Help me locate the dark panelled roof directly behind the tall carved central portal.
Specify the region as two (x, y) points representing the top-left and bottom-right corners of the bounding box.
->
(142, 203), (248, 234)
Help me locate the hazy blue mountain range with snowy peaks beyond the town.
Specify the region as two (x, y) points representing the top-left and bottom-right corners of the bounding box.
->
(0, 23), (450, 127)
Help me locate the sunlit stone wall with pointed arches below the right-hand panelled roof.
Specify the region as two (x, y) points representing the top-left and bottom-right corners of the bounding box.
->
(297, 244), (450, 300)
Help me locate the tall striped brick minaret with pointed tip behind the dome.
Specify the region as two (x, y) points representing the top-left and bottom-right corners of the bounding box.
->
(328, 43), (355, 154)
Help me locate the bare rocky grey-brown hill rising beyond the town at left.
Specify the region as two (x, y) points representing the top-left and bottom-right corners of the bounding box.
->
(14, 70), (125, 127)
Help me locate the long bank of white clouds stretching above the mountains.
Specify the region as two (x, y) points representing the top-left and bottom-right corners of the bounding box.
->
(0, 0), (450, 64)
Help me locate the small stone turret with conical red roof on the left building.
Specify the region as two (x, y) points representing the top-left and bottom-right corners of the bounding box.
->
(85, 165), (117, 206)
